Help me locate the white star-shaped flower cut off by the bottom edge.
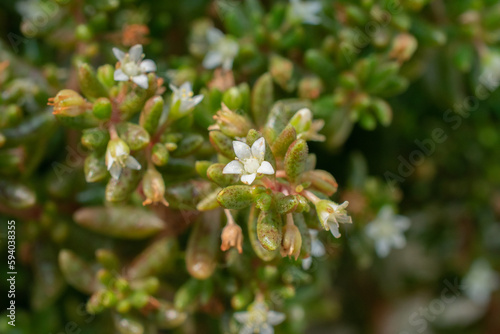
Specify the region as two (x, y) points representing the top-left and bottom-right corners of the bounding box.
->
(234, 301), (285, 334)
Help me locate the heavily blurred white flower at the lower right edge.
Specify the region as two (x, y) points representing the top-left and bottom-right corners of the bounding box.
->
(463, 259), (499, 305)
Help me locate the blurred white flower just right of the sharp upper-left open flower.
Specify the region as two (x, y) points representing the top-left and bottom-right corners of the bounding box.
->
(203, 28), (239, 71)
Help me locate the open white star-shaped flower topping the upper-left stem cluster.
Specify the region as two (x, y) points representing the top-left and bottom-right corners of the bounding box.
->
(113, 44), (156, 89)
